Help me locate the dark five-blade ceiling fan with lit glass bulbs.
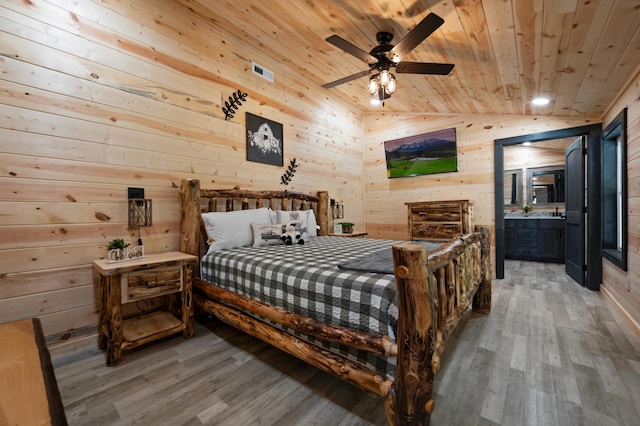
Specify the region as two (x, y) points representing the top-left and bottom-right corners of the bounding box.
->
(322, 13), (454, 101)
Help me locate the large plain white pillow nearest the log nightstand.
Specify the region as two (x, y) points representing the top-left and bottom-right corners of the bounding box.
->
(202, 207), (270, 254)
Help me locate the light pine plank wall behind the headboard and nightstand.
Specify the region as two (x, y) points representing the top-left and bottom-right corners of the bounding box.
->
(0, 0), (363, 335)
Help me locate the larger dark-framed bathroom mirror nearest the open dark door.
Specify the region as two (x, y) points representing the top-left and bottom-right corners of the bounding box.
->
(527, 166), (564, 206)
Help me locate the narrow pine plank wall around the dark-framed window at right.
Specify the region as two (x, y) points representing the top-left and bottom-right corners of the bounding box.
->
(602, 70), (640, 329)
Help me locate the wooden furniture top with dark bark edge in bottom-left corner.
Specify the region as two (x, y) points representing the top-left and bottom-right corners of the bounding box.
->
(0, 318), (67, 425)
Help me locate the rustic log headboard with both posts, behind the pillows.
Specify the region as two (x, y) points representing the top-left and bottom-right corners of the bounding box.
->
(180, 179), (329, 258)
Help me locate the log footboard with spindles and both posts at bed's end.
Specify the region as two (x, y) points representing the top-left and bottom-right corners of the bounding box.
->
(385, 228), (491, 425)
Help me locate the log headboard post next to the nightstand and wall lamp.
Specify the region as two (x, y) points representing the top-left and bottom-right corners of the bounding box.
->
(180, 179), (200, 256)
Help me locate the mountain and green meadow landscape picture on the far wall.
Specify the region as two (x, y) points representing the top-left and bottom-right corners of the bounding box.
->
(384, 128), (458, 178)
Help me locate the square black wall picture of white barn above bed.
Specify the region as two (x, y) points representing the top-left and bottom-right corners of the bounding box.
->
(246, 112), (284, 166)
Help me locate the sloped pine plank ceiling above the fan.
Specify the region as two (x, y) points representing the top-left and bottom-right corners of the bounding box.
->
(179, 0), (640, 117)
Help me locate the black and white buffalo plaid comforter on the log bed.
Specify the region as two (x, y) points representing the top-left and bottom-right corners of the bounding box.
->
(201, 237), (398, 377)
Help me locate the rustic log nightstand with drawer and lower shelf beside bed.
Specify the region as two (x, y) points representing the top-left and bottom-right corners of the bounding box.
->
(93, 252), (198, 366)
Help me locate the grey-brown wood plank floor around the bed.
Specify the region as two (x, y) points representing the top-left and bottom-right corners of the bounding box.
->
(53, 261), (640, 426)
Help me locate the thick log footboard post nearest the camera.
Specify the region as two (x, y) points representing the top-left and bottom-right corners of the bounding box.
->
(385, 244), (437, 426)
